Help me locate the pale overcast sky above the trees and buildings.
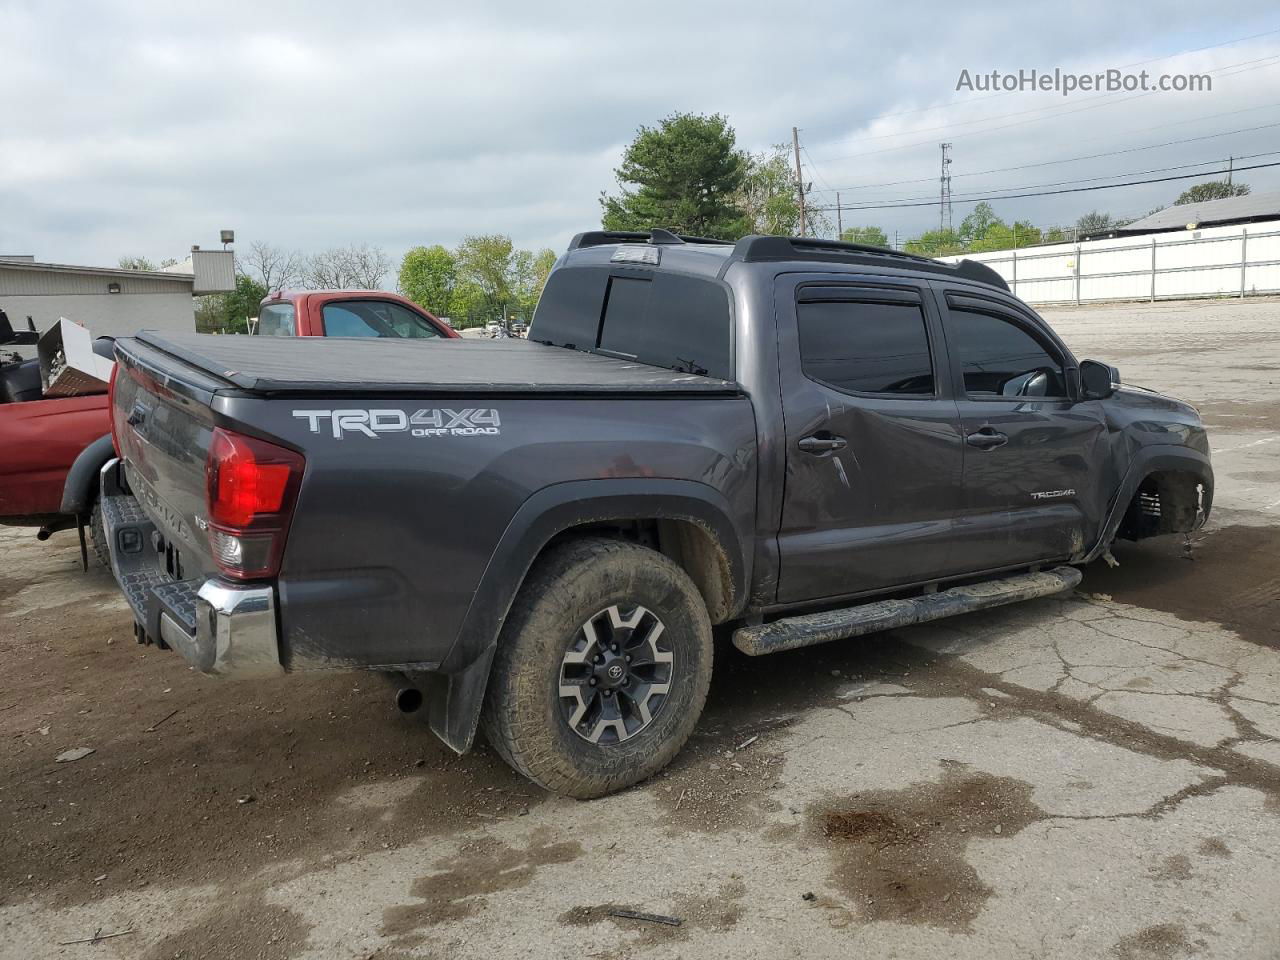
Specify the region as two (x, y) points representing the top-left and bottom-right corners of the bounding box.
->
(0, 0), (1280, 276)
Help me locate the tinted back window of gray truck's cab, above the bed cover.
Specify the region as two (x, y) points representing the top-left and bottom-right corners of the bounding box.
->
(530, 268), (733, 380)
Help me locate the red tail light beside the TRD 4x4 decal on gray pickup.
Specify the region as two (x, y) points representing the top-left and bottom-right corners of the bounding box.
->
(205, 426), (306, 580)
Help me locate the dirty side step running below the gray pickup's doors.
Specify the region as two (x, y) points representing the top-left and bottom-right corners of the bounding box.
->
(733, 567), (1083, 657)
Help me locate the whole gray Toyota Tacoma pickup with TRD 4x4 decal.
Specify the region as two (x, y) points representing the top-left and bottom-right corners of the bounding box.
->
(102, 230), (1213, 797)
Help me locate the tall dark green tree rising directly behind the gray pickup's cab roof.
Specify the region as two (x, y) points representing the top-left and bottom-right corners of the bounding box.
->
(600, 113), (750, 239)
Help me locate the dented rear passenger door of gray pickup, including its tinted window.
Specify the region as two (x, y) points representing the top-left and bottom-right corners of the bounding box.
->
(774, 275), (963, 603)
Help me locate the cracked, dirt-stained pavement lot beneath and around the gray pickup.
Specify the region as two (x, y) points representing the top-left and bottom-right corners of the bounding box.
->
(0, 300), (1280, 960)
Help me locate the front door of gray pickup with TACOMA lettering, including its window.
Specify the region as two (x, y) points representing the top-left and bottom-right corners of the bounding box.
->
(940, 287), (1103, 571)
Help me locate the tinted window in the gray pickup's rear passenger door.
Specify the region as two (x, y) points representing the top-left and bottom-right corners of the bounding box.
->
(796, 301), (933, 397)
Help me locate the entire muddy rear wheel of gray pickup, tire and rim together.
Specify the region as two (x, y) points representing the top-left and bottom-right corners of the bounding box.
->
(483, 538), (712, 799)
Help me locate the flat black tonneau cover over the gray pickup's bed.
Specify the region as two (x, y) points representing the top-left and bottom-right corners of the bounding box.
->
(137, 330), (739, 394)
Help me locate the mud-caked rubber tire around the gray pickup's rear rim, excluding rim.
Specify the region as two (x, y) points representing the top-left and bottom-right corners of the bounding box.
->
(483, 538), (712, 800)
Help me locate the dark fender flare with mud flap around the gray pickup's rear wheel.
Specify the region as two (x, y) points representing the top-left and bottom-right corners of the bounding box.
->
(415, 479), (750, 753)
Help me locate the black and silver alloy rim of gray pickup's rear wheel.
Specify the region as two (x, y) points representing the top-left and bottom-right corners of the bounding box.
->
(559, 604), (675, 744)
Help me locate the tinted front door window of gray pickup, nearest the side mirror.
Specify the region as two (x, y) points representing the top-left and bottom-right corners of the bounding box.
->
(945, 308), (1066, 397)
